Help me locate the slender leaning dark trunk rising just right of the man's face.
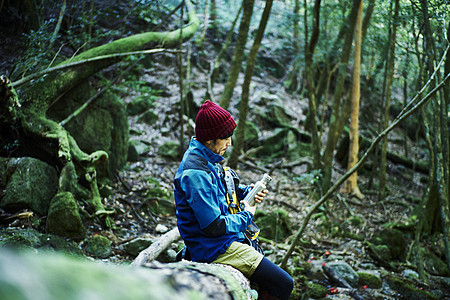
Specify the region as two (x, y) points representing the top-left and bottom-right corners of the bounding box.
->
(229, 0), (272, 168)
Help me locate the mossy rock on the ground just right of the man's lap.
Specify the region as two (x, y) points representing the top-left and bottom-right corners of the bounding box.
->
(255, 208), (291, 241)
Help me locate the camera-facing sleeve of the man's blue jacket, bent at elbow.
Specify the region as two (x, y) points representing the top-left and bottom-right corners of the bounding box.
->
(180, 170), (253, 236)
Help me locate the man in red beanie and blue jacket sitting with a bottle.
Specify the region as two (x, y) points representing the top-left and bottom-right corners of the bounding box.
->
(174, 101), (293, 299)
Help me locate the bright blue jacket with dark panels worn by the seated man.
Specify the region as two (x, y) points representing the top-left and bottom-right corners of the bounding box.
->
(174, 138), (253, 262)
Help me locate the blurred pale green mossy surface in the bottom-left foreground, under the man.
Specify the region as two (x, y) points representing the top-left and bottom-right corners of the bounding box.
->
(0, 249), (209, 300)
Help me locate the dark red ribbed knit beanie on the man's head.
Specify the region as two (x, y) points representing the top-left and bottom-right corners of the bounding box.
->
(195, 100), (236, 142)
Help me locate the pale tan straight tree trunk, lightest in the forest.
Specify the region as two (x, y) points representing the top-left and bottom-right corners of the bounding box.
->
(341, 0), (364, 199)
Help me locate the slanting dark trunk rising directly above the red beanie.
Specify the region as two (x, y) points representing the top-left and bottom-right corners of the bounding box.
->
(220, 0), (255, 109)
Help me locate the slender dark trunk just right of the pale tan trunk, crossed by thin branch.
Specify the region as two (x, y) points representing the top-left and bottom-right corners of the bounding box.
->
(378, 0), (400, 201)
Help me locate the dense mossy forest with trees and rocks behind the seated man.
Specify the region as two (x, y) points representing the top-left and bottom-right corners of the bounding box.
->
(0, 0), (450, 299)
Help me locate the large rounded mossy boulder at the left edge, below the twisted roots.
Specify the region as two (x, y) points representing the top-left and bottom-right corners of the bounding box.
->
(0, 157), (58, 216)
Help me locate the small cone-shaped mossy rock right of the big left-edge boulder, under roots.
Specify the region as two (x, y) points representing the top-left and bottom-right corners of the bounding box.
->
(46, 192), (86, 240)
